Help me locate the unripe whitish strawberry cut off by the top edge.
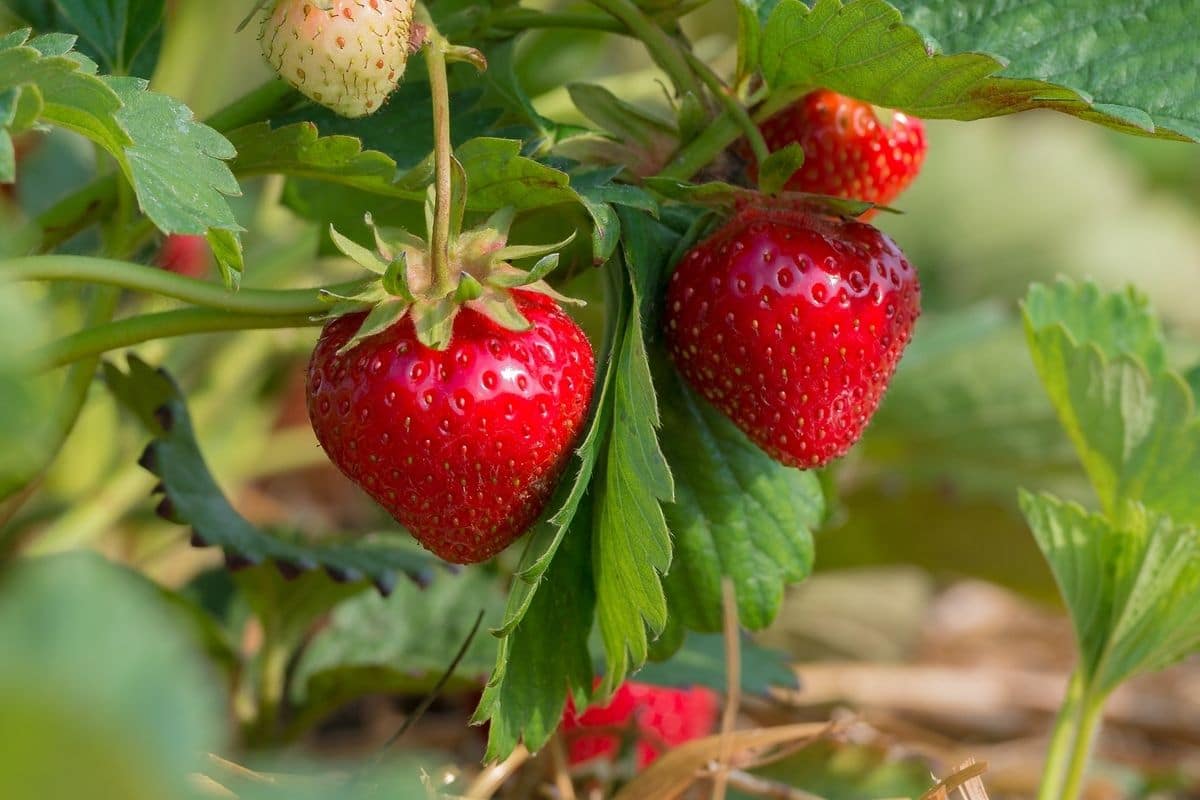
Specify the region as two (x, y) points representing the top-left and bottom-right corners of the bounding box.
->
(259, 0), (413, 116)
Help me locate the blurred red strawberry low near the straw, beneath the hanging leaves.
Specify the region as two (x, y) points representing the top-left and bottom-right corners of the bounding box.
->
(562, 681), (720, 769)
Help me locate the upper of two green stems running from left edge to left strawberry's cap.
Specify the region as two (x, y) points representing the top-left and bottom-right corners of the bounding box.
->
(0, 255), (362, 317)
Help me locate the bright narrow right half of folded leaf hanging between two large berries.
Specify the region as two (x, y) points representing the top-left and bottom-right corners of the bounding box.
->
(592, 213), (674, 694)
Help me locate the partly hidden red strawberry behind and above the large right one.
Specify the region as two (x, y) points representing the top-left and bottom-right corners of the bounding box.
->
(762, 89), (926, 219)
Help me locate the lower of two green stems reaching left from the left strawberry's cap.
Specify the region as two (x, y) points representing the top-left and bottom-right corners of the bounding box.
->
(30, 307), (328, 372)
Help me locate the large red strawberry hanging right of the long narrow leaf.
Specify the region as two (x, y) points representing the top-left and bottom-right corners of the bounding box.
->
(666, 207), (920, 468)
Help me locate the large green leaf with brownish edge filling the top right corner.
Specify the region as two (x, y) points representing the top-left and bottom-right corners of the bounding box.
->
(762, 0), (1200, 139)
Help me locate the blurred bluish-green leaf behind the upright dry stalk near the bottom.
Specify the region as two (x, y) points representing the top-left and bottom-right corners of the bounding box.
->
(636, 633), (799, 694)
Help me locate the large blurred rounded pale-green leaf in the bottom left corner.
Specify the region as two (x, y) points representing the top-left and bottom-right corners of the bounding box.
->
(0, 553), (224, 800)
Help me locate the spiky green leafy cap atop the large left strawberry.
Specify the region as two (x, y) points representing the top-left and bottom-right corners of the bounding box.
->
(323, 207), (583, 353)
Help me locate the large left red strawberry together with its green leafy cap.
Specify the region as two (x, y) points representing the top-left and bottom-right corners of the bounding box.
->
(307, 212), (595, 564)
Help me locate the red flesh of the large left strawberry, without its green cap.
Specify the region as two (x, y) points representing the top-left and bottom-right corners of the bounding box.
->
(307, 290), (595, 564)
